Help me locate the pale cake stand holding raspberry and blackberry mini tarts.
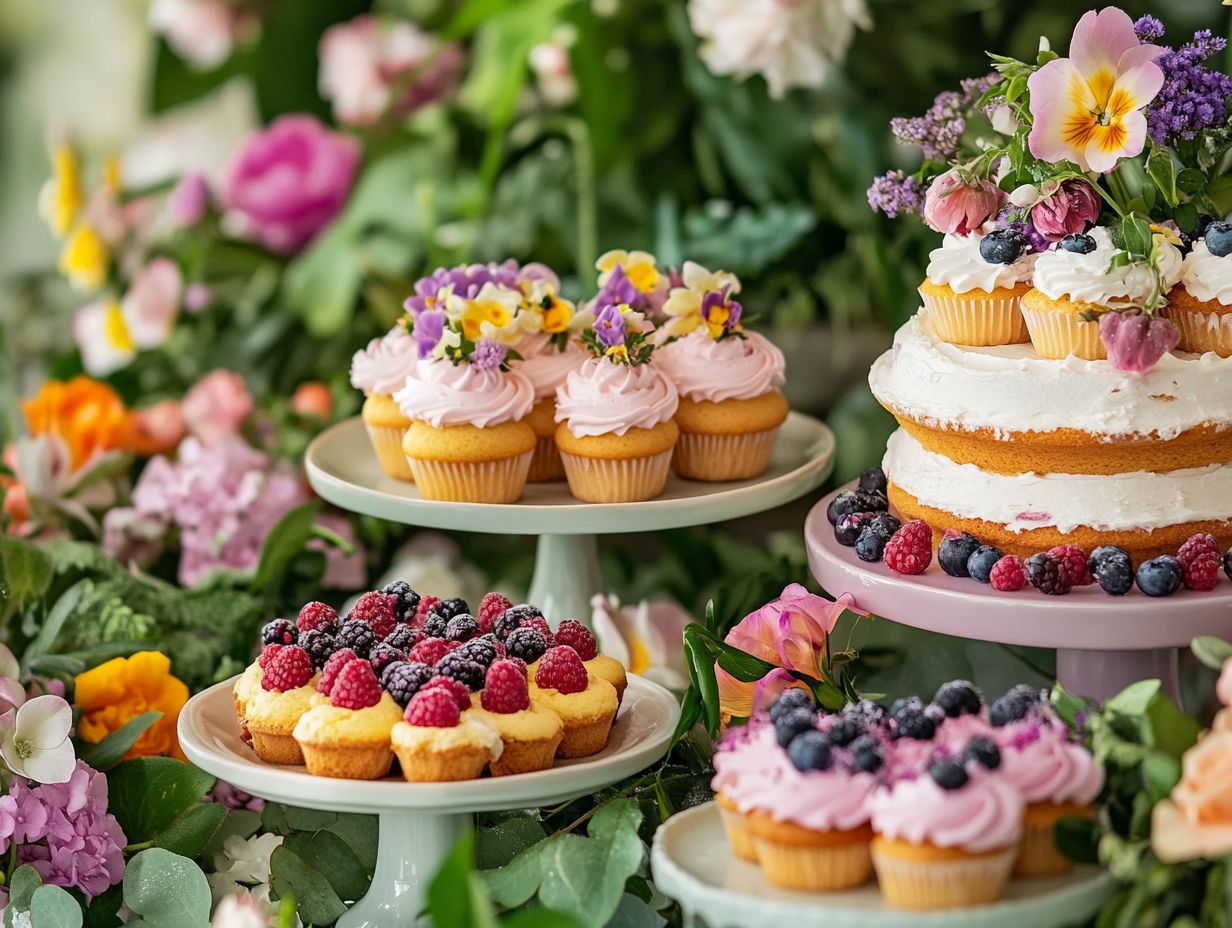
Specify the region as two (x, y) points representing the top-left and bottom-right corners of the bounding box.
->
(179, 675), (680, 928)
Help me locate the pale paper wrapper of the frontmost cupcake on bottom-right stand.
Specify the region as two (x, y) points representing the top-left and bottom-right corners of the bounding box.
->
(872, 844), (1018, 911)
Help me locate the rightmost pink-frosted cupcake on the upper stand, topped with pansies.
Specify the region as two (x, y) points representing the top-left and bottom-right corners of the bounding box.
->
(657, 261), (787, 481)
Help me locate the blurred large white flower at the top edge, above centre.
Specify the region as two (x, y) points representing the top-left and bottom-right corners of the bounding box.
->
(689, 0), (870, 97)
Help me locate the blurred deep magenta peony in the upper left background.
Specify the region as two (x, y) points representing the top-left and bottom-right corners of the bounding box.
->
(222, 115), (360, 254)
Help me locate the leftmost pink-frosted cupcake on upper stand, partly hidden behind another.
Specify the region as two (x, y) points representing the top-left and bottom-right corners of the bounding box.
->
(351, 325), (419, 481)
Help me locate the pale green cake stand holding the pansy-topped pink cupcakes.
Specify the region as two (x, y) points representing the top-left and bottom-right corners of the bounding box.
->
(304, 413), (834, 621)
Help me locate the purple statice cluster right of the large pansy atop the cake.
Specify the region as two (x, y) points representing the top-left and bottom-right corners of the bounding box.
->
(1138, 29), (1232, 145)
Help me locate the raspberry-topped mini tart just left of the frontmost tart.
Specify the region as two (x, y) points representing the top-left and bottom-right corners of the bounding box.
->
(294, 658), (402, 780)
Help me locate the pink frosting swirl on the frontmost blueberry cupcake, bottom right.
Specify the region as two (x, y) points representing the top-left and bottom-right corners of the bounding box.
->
(869, 770), (1023, 854)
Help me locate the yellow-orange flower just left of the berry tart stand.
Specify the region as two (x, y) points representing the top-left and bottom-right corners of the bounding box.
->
(75, 651), (188, 760)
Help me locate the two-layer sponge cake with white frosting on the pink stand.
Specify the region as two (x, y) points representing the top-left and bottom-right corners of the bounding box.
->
(869, 315), (1232, 561)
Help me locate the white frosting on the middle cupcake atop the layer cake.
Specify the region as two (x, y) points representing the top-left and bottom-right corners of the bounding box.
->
(1032, 227), (1181, 308)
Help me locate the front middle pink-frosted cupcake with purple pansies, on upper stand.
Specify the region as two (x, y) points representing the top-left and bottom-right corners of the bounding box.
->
(556, 303), (679, 503)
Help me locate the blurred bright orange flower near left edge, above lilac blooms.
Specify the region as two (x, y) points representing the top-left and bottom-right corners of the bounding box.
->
(21, 377), (131, 471)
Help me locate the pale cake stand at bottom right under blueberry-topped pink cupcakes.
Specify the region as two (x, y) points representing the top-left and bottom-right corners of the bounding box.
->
(650, 802), (1114, 928)
